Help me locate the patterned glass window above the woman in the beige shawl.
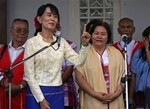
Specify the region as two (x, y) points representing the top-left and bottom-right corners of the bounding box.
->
(80, 0), (114, 42)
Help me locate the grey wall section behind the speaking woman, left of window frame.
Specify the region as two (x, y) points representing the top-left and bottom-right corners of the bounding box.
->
(7, 0), (69, 42)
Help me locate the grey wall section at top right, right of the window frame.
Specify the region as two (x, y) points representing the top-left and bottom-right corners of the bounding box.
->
(121, 0), (150, 40)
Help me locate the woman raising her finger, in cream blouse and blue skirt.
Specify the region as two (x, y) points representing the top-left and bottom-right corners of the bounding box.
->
(24, 3), (90, 109)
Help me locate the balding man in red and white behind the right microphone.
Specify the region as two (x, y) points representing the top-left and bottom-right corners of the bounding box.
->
(113, 18), (143, 108)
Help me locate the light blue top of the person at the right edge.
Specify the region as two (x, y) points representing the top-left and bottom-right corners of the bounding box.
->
(131, 49), (150, 92)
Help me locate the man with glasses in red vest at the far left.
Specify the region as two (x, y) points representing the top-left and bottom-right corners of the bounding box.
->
(0, 18), (29, 109)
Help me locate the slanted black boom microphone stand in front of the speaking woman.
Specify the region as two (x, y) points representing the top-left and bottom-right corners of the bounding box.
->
(4, 37), (58, 109)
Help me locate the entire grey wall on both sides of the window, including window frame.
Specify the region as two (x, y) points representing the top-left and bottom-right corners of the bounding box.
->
(7, 0), (150, 44)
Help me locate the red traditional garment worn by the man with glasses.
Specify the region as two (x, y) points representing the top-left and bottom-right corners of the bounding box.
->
(0, 48), (26, 109)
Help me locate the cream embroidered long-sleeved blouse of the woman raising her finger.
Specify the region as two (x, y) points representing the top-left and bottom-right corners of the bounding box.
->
(24, 33), (90, 102)
